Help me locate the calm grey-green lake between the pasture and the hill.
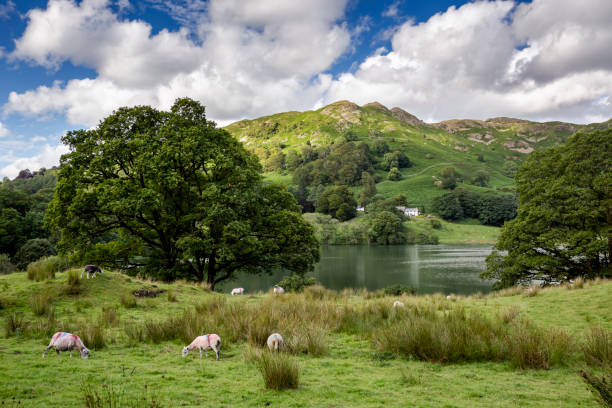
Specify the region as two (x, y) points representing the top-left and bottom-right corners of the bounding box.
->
(218, 245), (492, 295)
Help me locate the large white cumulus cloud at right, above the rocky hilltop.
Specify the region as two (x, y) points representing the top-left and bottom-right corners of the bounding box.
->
(325, 0), (612, 122)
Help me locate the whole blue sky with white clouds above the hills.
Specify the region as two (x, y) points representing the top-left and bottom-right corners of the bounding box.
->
(0, 0), (612, 178)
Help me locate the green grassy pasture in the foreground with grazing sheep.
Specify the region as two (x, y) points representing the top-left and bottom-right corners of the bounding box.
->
(0, 272), (612, 407)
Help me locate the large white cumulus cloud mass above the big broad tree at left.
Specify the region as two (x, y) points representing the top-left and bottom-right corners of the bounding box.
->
(5, 0), (350, 126)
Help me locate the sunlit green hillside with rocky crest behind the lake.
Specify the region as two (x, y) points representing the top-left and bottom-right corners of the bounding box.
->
(226, 101), (612, 211)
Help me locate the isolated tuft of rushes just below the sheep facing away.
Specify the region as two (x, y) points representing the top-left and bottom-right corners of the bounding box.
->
(256, 351), (300, 391)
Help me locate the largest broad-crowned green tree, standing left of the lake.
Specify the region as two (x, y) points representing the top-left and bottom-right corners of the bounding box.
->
(46, 99), (319, 288)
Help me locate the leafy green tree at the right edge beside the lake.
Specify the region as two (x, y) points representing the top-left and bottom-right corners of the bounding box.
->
(482, 130), (612, 287)
